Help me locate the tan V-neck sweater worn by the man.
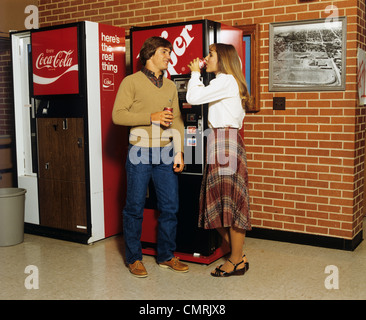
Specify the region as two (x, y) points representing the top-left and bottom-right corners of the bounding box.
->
(112, 71), (184, 153)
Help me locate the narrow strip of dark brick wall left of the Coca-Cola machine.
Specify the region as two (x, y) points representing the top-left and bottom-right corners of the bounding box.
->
(0, 40), (14, 136)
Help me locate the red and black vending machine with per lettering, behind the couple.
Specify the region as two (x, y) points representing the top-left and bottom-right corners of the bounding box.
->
(130, 20), (245, 263)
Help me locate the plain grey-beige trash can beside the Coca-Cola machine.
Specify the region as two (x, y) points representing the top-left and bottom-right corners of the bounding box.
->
(0, 188), (27, 247)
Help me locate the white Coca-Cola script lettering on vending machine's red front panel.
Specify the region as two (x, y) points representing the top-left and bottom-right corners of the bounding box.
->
(36, 49), (74, 69)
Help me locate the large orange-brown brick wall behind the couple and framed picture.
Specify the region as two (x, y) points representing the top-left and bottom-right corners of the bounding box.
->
(39, 0), (366, 239)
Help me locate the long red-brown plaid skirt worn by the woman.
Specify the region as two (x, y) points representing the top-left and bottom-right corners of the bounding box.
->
(198, 128), (251, 230)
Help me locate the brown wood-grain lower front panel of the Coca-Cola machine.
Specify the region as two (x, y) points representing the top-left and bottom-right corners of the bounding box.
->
(37, 118), (88, 233)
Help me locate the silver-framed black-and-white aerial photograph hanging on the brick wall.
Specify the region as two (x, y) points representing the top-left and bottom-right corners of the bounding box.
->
(269, 17), (347, 91)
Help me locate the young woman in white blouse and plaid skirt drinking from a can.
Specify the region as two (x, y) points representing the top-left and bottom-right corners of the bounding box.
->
(187, 43), (252, 277)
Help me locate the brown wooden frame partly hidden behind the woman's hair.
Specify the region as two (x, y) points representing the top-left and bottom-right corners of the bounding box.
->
(235, 24), (260, 113)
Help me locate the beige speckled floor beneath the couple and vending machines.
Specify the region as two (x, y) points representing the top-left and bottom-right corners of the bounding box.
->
(0, 219), (366, 300)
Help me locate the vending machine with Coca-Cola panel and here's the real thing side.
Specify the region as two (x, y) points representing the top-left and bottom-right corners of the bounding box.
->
(11, 21), (128, 243)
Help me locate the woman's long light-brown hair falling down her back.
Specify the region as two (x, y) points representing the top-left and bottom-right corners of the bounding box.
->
(210, 43), (253, 111)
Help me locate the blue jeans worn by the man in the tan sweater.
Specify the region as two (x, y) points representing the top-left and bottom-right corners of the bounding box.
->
(123, 145), (179, 264)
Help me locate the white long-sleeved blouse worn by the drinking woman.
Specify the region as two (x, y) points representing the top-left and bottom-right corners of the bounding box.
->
(186, 71), (245, 129)
